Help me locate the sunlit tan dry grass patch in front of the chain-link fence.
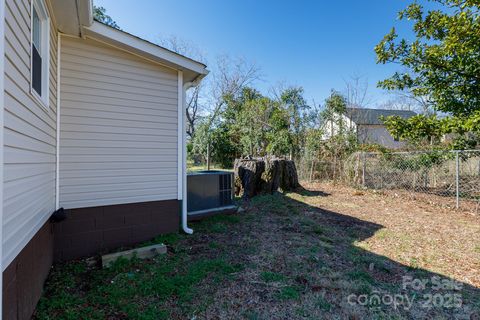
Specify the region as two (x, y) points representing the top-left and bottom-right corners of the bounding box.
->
(307, 183), (480, 287)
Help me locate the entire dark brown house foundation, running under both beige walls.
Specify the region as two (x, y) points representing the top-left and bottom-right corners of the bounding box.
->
(2, 200), (180, 320)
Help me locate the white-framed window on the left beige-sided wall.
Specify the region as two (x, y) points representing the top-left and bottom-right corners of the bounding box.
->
(30, 0), (50, 107)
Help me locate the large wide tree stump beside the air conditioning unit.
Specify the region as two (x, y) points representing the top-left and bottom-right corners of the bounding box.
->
(233, 157), (300, 199)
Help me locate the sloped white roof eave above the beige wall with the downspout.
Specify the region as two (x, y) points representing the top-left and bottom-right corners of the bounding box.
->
(83, 21), (208, 82)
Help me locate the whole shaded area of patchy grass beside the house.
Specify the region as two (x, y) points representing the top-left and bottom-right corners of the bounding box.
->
(36, 185), (480, 320)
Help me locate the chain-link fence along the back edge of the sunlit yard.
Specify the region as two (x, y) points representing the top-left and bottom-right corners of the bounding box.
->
(297, 150), (480, 212)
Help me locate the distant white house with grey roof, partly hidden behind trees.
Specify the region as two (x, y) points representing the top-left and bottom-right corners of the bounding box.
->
(323, 108), (416, 149)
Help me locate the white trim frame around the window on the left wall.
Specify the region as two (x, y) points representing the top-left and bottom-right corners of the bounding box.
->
(30, 0), (50, 110)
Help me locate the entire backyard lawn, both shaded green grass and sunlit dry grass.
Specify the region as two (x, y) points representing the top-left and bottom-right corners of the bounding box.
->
(35, 184), (480, 319)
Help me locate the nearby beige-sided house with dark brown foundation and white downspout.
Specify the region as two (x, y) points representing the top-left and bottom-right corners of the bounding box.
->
(0, 0), (208, 320)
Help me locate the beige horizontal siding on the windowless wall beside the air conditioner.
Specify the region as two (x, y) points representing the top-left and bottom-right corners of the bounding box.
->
(60, 37), (178, 209)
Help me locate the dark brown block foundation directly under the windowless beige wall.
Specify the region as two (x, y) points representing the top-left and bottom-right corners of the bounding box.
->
(54, 200), (180, 262)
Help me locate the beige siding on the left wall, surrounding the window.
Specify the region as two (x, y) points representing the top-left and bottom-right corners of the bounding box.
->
(3, 0), (57, 268)
